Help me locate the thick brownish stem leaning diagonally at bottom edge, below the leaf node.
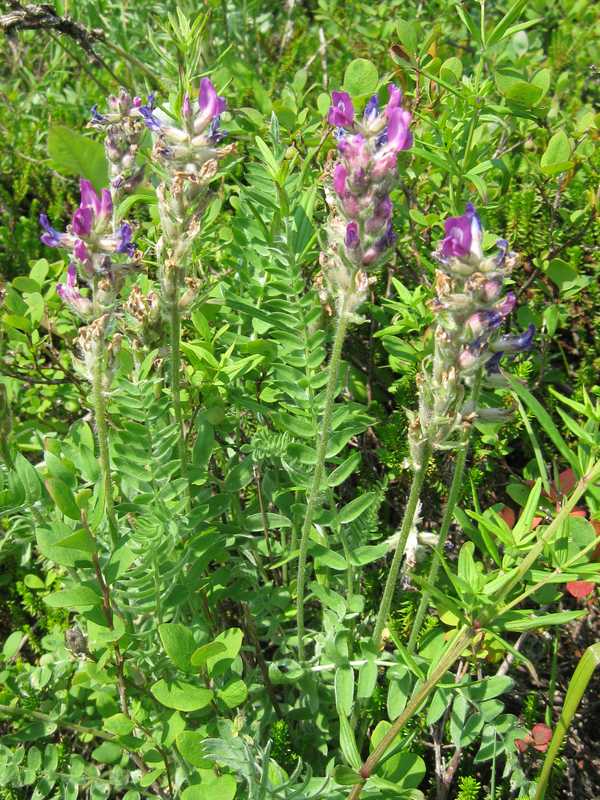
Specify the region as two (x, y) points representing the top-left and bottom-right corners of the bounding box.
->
(348, 627), (474, 800)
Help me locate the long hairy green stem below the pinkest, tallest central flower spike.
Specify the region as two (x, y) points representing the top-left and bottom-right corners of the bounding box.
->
(296, 297), (349, 661)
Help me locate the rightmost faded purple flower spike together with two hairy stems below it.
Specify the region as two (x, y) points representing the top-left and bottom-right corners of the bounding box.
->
(373, 204), (535, 647)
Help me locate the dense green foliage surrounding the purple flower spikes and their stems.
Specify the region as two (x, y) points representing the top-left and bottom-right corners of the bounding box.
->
(0, 0), (600, 800)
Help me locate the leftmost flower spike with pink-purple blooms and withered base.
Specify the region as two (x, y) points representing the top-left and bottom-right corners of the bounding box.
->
(40, 178), (135, 318)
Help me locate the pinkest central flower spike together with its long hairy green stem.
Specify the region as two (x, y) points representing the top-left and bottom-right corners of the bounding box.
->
(296, 85), (412, 661)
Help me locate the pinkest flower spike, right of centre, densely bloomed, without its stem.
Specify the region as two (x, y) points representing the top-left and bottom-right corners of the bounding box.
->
(321, 85), (412, 316)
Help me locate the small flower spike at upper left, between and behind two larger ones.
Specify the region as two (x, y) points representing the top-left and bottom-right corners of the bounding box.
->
(90, 89), (149, 196)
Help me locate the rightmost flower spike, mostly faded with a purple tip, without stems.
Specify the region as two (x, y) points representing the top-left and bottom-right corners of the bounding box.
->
(409, 204), (535, 466)
